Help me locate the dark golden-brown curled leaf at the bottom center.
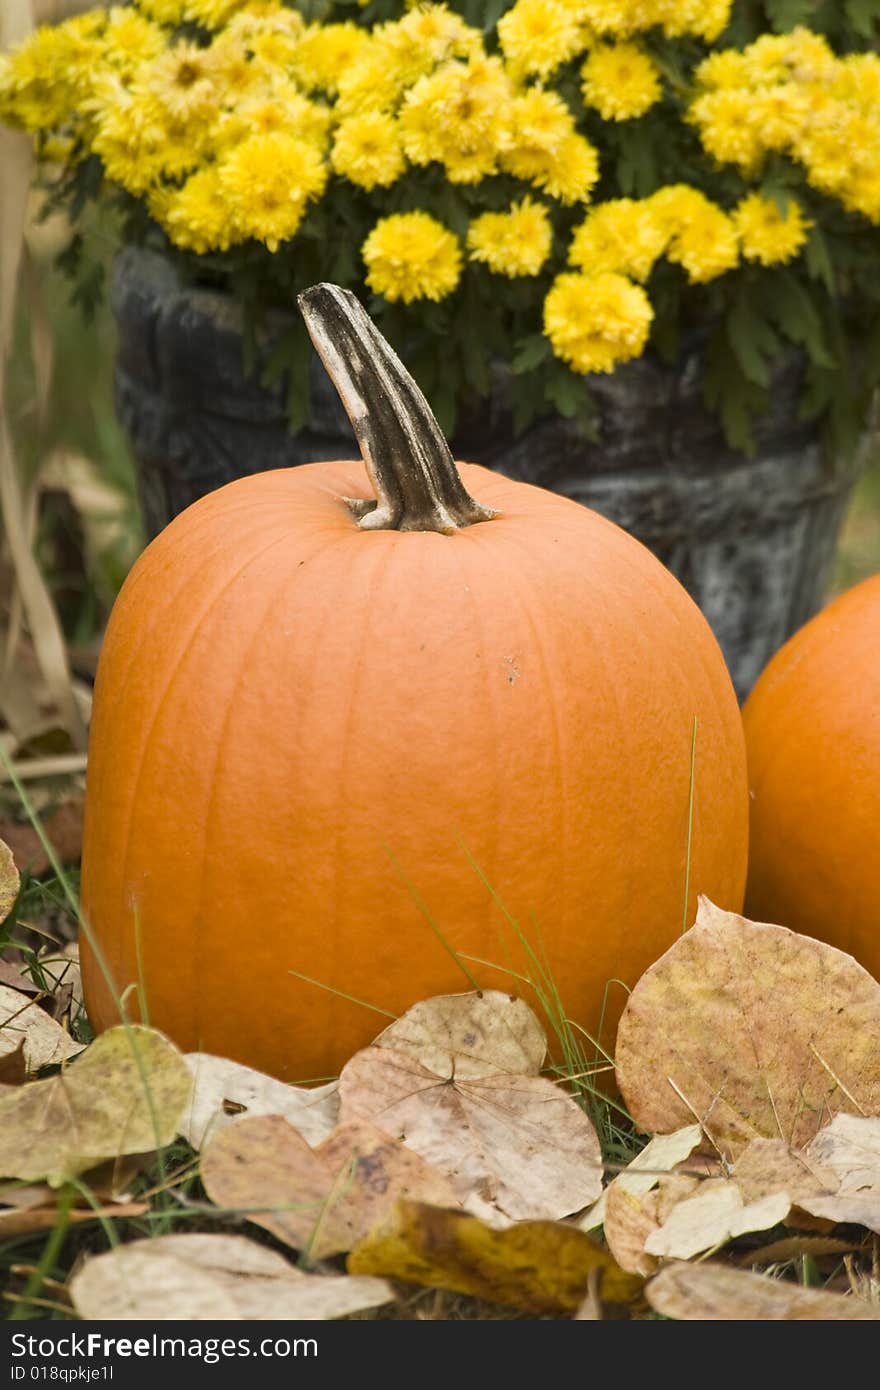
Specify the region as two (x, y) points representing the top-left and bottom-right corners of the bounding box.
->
(348, 1201), (642, 1314)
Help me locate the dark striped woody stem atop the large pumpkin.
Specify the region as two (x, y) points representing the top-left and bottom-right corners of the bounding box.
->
(298, 285), (498, 535)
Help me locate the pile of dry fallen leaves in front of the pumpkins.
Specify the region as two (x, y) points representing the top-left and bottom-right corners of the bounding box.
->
(0, 859), (880, 1321)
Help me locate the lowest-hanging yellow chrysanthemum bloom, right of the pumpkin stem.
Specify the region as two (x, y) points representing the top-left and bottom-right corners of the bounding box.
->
(544, 271), (653, 373)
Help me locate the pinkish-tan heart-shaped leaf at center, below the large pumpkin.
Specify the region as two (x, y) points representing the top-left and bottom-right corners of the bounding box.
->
(339, 1047), (602, 1220)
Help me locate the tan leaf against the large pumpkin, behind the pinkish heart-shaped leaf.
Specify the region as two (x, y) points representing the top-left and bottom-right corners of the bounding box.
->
(374, 990), (546, 1081)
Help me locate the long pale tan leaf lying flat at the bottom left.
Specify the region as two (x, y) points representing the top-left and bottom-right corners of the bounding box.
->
(70, 1236), (393, 1322)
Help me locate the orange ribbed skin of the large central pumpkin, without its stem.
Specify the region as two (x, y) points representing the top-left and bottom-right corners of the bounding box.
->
(82, 461), (748, 1080)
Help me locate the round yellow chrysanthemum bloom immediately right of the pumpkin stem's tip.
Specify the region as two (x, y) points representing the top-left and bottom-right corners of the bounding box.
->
(363, 213), (462, 304)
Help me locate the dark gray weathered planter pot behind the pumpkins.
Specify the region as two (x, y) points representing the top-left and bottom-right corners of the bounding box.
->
(113, 247), (858, 699)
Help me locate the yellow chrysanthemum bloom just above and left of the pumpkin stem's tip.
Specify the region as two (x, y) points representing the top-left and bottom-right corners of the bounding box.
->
(218, 131), (327, 252)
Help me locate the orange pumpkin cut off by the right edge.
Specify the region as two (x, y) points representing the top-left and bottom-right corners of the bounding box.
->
(742, 575), (880, 979)
